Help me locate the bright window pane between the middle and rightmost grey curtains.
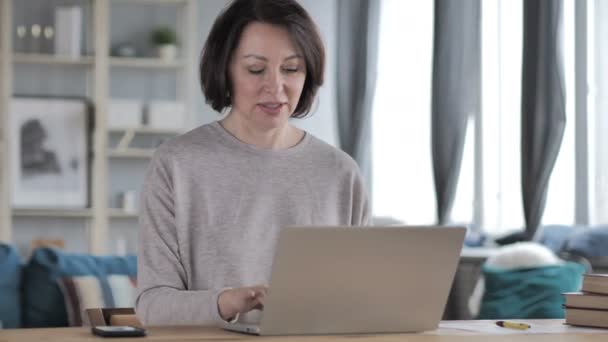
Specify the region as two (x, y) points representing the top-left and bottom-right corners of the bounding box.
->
(479, 0), (524, 235)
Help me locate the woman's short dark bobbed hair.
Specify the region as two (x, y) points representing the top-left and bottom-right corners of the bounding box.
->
(199, 0), (325, 118)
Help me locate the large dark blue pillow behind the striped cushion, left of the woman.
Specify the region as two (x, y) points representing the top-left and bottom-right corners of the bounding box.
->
(22, 248), (137, 328)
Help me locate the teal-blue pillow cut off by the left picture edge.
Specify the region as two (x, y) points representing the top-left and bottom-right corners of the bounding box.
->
(0, 243), (21, 329)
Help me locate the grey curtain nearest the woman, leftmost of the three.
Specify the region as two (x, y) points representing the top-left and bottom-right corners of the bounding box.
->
(336, 0), (380, 198)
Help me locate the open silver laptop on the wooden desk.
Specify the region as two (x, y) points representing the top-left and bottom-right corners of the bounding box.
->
(224, 226), (465, 335)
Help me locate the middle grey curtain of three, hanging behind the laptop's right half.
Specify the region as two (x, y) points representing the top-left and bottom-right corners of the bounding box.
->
(431, 0), (481, 224)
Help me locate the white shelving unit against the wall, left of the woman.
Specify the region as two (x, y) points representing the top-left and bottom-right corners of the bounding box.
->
(0, 0), (200, 254)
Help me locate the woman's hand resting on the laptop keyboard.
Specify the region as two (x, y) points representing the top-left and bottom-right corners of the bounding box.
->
(217, 285), (268, 321)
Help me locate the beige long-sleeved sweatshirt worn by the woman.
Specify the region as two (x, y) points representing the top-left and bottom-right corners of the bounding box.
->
(136, 122), (369, 325)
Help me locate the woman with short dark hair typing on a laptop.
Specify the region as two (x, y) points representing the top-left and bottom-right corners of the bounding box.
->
(136, 0), (369, 325)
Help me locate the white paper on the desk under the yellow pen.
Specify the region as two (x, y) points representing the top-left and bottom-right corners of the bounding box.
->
(439, 321), (607, 335)
